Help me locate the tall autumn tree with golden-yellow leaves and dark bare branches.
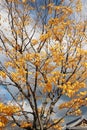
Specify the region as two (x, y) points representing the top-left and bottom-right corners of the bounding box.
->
(0, 0), (87, 130)
